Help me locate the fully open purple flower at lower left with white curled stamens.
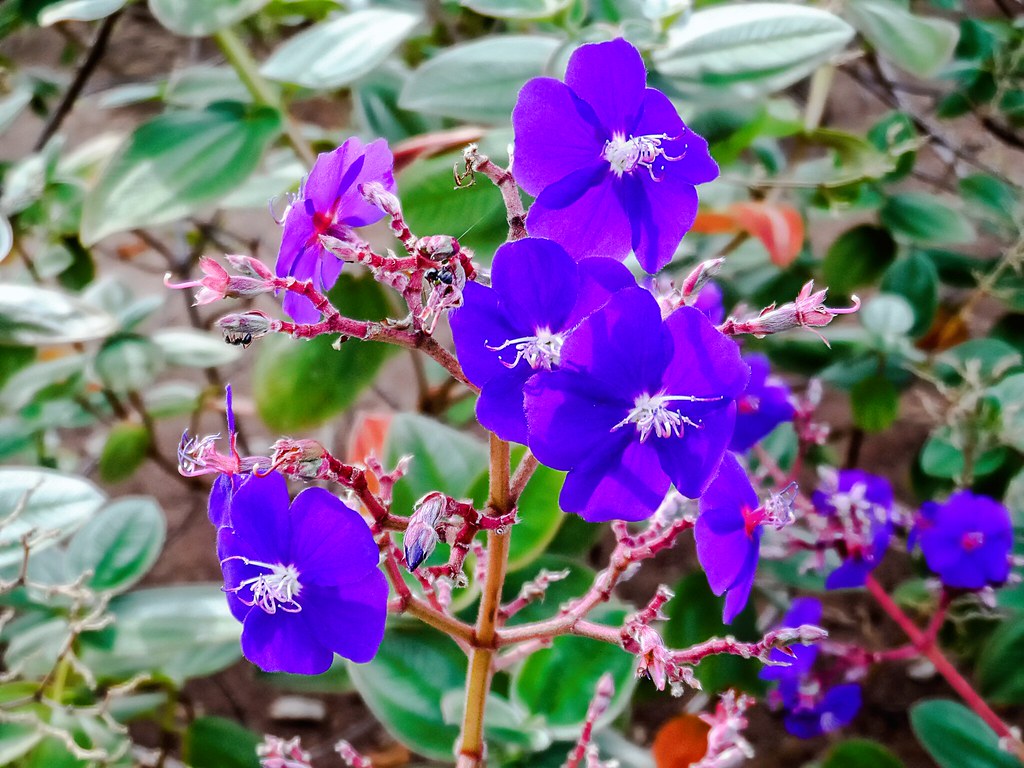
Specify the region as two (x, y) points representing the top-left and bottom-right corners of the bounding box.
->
(217, 472), (387, 675)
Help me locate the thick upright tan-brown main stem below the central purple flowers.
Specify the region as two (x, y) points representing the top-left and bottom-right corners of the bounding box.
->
(457, 434), (512, 768)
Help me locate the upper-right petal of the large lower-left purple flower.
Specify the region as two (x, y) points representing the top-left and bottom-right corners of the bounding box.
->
(288, 487), (380, 587)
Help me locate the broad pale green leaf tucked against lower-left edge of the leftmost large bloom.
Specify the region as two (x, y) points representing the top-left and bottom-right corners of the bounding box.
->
(82, 583), (242, 683)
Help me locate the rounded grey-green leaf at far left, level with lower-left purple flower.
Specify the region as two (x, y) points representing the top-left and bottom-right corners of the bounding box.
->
(67, 496), (167, 592)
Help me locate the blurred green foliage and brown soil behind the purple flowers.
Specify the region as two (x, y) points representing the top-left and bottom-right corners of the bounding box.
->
(0, 0), (1024, 768)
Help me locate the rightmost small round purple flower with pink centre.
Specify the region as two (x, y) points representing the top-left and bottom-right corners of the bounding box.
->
(914, 490), (1014, 590)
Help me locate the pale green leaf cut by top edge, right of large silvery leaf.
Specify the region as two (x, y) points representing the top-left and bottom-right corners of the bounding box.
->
(846, 0), (959, 78)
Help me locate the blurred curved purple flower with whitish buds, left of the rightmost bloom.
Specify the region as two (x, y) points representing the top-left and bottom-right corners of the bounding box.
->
(812, 469), (893, 590)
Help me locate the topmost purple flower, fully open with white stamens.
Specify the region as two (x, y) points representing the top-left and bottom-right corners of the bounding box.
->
(512, 39), (718, 273)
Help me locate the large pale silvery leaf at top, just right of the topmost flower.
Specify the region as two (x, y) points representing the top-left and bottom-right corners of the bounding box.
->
(653, 3), (853, 97)
